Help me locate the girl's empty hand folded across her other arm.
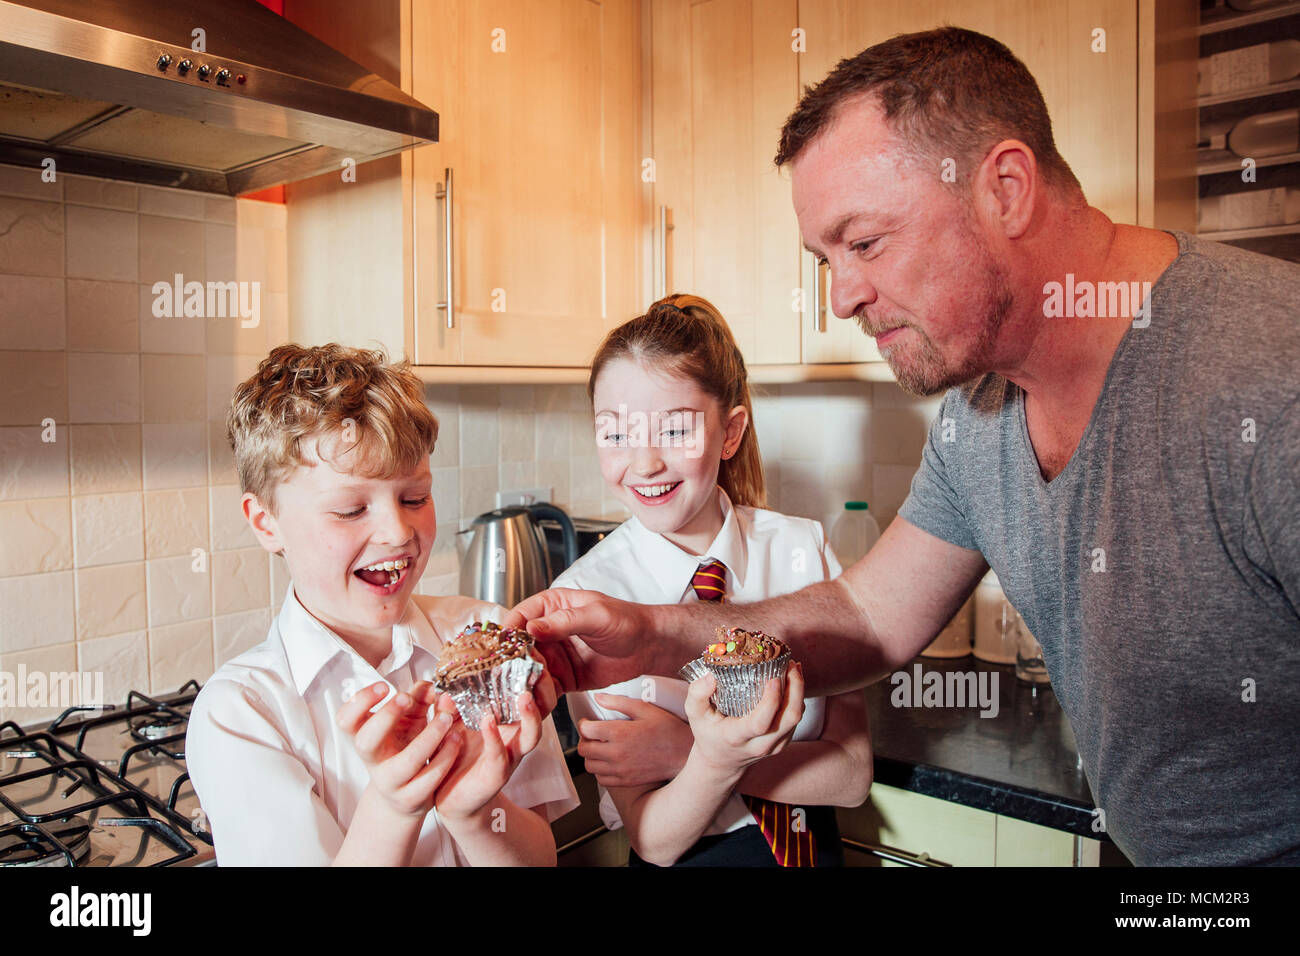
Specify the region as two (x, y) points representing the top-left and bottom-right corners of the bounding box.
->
(577, 693), (694, 787)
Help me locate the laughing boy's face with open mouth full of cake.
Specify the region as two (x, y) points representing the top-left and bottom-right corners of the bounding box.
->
(248, 440), (437, 639)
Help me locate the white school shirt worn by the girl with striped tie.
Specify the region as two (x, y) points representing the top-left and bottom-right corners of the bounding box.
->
(551, 486), (841, 836)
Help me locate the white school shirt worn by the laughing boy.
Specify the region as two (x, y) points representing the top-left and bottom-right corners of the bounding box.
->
(186, 584), (579, 866)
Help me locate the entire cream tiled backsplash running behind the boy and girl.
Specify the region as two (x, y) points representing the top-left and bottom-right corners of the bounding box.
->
(0, 165), (939, 722)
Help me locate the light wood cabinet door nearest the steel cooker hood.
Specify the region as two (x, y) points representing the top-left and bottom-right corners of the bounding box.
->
(412, 0), (640, 365)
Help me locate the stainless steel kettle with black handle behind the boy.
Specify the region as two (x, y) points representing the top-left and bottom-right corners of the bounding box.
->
(460, 502), (577, 607)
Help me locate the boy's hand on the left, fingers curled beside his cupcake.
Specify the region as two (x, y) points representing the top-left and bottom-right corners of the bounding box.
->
(338, 680), (465, 817)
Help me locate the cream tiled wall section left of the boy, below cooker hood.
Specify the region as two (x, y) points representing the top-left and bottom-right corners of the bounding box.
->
(0, 166), (289, 721)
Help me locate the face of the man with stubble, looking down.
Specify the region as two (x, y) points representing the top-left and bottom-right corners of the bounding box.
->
(790, 98), (1013, 395)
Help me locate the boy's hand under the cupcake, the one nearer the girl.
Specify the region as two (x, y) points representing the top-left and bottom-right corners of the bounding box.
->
(434, 693), (542, 821)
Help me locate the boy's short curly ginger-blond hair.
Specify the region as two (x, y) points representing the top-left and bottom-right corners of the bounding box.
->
(226, 342), (438, 514)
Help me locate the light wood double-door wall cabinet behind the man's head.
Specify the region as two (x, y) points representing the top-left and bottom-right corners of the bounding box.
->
(651, 0), (1195, 377)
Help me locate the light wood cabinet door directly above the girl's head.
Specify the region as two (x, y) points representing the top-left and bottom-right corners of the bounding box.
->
(650, 0), (800, 364)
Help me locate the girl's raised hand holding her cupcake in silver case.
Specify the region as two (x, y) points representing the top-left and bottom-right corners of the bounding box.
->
(686, 663), (803, 777)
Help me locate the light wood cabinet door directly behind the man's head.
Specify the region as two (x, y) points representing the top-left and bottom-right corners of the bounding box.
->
(800, 0), (1138, 362)
